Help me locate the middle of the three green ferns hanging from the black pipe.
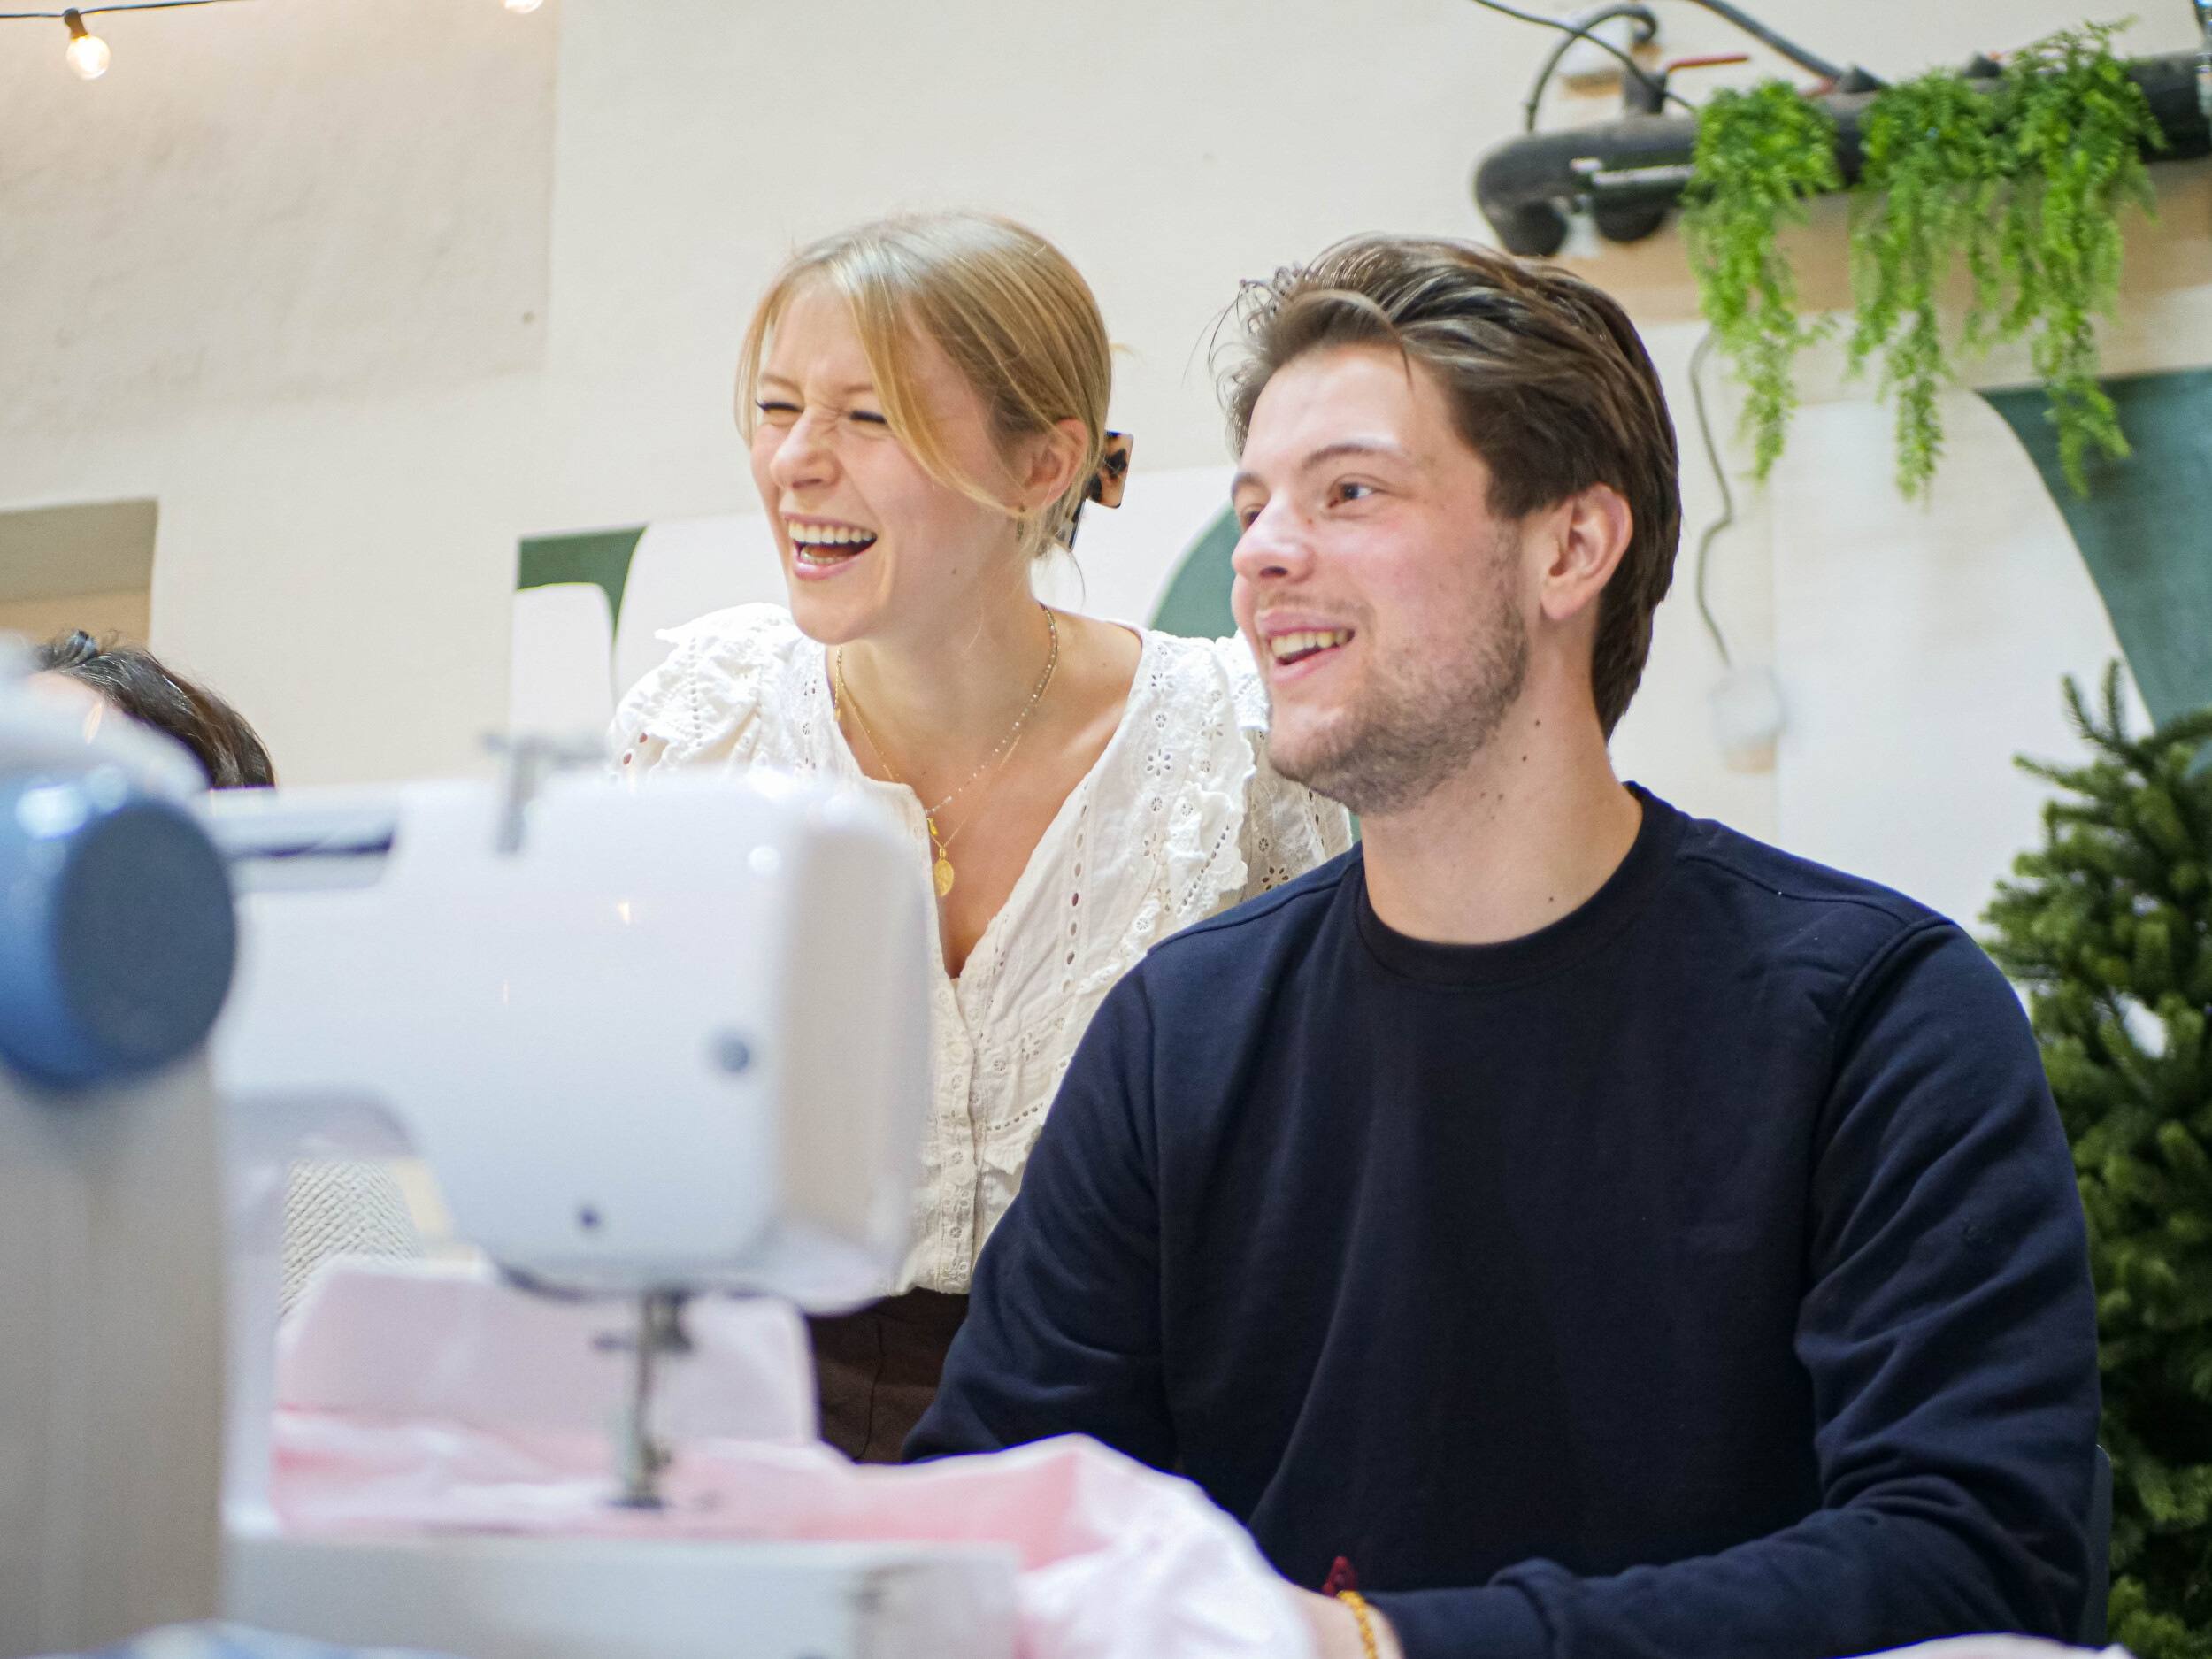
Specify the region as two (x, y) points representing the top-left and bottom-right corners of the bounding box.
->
(1849, 71), (2004, 500)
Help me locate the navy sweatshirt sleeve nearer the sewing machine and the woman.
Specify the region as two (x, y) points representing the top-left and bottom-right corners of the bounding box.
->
(905, 967), (1175, 1469)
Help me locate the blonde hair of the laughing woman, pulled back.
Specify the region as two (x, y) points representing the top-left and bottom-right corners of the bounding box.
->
(737, 212), (1113, 556)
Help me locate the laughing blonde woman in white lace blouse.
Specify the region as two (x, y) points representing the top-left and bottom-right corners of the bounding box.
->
(615, 215), (1349, 1463)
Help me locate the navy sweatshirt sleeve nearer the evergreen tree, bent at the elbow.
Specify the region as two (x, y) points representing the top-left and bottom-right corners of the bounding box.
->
(1374, 920), (2100, 1659)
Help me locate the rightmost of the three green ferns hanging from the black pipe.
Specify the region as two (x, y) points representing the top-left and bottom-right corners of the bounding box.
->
(2000, 22), (2166, 495)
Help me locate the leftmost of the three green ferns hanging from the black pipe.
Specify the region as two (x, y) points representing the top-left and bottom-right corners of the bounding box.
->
(1684, 80), (1843, 478)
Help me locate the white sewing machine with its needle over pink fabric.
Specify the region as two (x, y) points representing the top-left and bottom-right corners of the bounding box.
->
(208, 746), (1013, 1659)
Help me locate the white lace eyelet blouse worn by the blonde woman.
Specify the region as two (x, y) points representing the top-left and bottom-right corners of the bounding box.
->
(615, 604), (1352, 1292)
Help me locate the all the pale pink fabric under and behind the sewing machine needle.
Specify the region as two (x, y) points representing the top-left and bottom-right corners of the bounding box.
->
(254, 1263), (2128, 1659)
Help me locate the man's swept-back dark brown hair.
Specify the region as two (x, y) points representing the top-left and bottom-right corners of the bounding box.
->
(1224, 237), (1681, 737)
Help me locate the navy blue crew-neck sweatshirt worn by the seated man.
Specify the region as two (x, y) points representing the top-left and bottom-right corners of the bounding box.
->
(907, 792), (2097, 1659)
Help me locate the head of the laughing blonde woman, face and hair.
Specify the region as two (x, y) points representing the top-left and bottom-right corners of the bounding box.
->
(737, 215), (1113, 644)
